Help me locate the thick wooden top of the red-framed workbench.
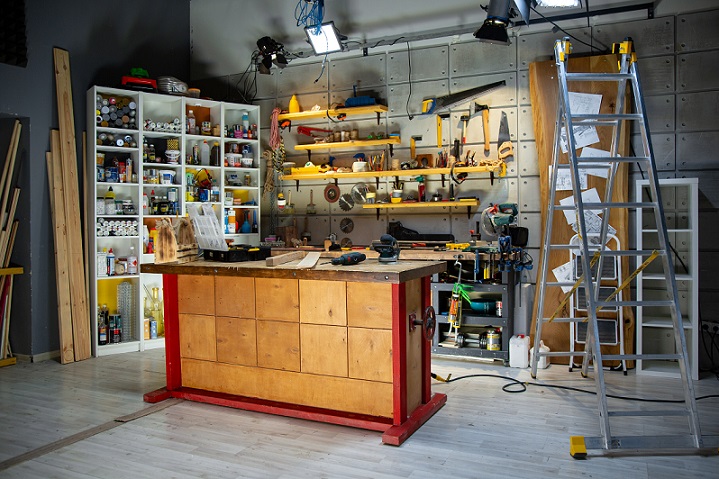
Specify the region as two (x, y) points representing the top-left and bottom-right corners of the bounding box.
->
(140, 255), (447, 283)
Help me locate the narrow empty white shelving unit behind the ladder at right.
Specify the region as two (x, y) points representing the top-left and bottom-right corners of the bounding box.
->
(635, 178), (701, 380)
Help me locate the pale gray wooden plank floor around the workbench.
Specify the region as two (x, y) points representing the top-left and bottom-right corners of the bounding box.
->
(0, 350), (719, 479)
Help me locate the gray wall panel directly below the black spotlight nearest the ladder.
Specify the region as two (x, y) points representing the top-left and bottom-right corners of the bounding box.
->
(449, 40), (517, 78)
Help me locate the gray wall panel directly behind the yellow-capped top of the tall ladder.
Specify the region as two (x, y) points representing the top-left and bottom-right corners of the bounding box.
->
(592, 17), (674, 58)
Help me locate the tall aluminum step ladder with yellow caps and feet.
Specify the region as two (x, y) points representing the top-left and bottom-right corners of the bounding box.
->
(531, 38), (719, 458)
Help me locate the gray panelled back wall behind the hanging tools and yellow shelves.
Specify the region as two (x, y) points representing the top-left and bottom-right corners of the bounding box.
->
(194, 10), (719, 372)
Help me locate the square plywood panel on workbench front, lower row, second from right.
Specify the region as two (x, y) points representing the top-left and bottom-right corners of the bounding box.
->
(300, 324), (348, 378)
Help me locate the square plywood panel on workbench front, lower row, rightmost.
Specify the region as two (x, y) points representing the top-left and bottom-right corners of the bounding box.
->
(347, 328), (392, 383)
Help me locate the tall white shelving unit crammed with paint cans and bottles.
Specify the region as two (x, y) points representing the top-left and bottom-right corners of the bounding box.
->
(86, 86), (261, 356)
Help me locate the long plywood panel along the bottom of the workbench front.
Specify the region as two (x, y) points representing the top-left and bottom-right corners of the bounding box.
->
(182, 358), (392, 417)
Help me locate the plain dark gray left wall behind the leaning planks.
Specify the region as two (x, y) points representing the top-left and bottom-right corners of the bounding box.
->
(0, 0), (190, 356)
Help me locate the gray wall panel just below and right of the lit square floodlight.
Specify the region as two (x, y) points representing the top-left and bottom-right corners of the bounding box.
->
(329, 53), (387, 90)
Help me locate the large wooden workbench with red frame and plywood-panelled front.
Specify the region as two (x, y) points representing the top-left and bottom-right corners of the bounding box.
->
(141, 258), (447, 445)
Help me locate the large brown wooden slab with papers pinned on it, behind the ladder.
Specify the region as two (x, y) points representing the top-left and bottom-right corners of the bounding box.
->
(529, 55), (634, 364)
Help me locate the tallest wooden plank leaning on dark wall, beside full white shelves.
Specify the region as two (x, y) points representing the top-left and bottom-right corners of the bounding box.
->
(53, 48), (90, 361)
